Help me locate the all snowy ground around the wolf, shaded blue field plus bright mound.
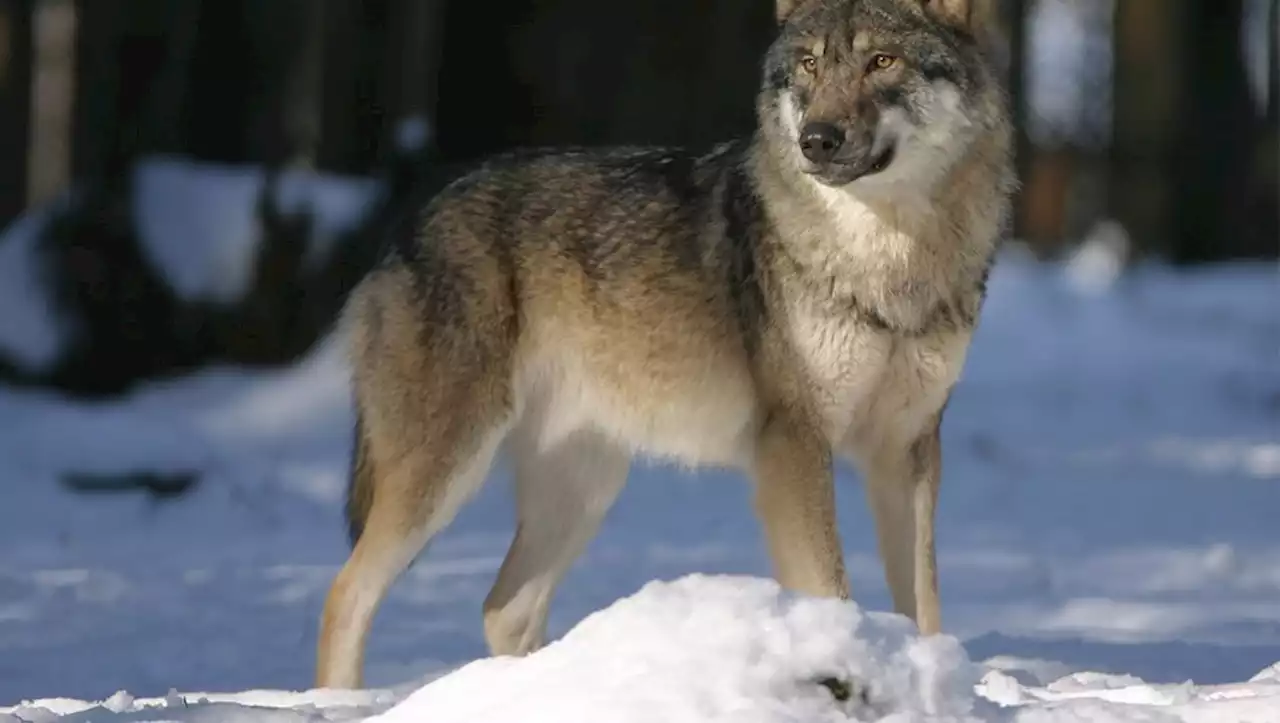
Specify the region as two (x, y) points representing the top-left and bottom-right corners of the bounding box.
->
(0, 217), (1280, 723)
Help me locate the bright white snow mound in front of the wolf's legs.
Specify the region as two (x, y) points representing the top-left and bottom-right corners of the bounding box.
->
(371, 575), (993, 723)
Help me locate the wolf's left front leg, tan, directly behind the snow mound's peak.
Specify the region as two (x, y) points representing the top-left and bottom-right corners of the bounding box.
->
(754, 416), (849, 598)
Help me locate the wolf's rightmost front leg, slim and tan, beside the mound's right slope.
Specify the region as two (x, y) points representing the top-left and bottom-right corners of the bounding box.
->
(851, 421), (942, 635)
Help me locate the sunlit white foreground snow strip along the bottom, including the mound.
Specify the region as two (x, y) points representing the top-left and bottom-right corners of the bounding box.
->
(12, 576), (1280, 723)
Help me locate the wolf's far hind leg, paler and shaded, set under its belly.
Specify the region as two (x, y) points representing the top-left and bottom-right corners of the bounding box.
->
(484, 424), (630, 655)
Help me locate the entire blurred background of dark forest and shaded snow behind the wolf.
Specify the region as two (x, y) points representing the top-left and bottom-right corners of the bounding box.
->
(0, 0), (1280, 706)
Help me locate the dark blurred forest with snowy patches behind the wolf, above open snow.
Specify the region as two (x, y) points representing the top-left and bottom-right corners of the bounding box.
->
(0, 0), (1280, 394)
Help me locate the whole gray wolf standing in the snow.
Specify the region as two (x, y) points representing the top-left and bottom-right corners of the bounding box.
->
(316, 0), (1014, 687)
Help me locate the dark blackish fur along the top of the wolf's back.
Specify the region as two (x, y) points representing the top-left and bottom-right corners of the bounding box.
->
(412, 142), (746, 280)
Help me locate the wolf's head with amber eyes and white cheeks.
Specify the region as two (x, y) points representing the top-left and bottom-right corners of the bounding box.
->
(760, 0), (1009, 191)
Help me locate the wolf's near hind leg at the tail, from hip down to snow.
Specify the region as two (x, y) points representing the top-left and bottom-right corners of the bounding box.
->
(316, 261), (515, 688)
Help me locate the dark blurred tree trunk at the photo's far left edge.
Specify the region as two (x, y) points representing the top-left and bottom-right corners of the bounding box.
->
(0, 0), (35, 223)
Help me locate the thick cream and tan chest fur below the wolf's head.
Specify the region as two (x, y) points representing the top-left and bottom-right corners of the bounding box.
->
(781, 182), (978, 450)
